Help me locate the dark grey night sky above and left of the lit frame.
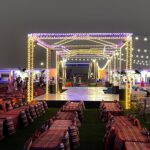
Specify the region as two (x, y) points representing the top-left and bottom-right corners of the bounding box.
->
(0, 0), (150, 68)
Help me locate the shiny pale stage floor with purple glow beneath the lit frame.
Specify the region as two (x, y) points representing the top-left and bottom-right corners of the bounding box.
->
(35, 87), (119, 101)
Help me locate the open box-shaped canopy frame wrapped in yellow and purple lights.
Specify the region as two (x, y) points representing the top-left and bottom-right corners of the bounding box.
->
(28, 33), (133, 109)
